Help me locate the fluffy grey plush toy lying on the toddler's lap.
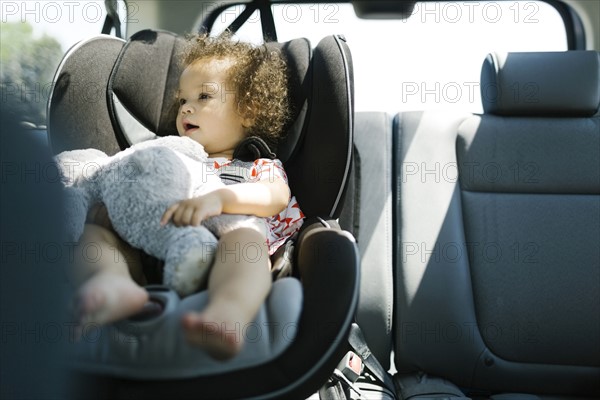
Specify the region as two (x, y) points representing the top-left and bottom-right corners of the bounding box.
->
(56, 136), (252, 296)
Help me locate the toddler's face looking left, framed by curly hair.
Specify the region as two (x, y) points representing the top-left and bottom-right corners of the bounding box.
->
(177, 59), (246, 158)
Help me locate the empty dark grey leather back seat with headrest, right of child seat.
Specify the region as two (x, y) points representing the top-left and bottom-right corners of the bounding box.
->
(394, 51), (600, 398)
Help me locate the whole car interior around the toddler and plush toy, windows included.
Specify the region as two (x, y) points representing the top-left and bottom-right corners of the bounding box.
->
(0, 0), (600, 400)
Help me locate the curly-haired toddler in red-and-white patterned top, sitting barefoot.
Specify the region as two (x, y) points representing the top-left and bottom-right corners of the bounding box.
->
(75, 34), (304, 359)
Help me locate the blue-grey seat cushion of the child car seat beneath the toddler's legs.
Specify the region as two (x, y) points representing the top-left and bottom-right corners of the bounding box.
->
(72, 278), (302, 378)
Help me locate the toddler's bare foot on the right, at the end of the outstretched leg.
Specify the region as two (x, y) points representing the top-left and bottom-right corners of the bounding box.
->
(181, 303), (249, 361)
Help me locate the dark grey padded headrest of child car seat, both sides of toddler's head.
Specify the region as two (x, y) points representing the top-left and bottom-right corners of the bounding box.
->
(108, 30), (311, 162)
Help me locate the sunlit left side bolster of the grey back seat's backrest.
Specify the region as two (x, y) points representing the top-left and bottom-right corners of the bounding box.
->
(393, 112), (485, 386)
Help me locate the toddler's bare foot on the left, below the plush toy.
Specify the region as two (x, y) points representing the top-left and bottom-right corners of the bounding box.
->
(74, 272), (148, 327)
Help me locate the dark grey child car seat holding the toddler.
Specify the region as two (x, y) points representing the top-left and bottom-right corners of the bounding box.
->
(48, 31), (358, 399)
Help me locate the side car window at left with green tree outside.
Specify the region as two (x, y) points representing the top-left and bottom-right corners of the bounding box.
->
(0, 0), (131, 126)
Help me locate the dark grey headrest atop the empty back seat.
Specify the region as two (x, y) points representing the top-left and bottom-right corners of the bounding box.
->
(481, 51), (600, 117)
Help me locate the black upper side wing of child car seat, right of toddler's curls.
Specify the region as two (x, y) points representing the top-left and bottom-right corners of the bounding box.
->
(285, 36), (354, 219)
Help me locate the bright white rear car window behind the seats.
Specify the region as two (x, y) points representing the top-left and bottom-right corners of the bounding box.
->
(213, 1), (567, 113)
